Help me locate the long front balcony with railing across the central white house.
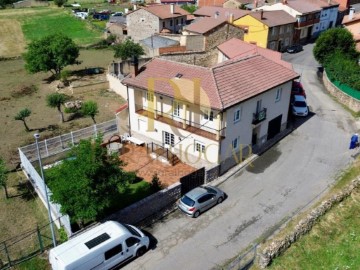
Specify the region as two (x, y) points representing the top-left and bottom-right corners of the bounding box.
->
(135, 105), (226, 141)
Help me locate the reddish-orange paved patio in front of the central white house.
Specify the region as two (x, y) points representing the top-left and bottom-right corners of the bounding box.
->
(119, 143), (196, 186)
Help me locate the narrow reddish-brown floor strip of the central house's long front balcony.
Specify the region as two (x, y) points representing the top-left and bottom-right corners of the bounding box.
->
(136, 109), (223, 141)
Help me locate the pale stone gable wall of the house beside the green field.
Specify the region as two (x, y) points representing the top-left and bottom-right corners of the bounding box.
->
(127, 9), (160, 41)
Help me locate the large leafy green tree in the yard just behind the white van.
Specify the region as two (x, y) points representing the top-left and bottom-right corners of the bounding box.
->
(46, 136), (134, 226)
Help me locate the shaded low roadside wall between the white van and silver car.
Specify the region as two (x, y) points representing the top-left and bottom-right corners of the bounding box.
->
(106, 182), (181, 226)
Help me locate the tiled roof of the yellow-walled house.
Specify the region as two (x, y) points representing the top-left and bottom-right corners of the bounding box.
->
(249, 10), (296, 27)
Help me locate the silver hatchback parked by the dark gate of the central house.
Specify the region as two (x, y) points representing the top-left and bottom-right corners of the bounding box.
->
(178, 186), (225, 218)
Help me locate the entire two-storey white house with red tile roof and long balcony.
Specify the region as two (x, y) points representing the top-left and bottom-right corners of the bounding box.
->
(123, 55), (299, 172)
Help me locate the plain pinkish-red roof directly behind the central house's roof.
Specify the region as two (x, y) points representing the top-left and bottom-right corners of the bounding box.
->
(218, 38), (292, 69)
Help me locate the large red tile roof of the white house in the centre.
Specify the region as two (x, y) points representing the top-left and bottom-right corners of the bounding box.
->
(123, 55), (299, 110)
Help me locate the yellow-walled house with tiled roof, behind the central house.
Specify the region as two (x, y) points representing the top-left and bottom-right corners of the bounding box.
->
(234, 10), (296, 51)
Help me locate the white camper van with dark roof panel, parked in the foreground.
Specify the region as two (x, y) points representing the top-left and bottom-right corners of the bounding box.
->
(49, 221), (150, 270)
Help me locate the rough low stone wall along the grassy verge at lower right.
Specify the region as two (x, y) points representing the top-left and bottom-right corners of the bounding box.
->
(258, 177), (360, 269)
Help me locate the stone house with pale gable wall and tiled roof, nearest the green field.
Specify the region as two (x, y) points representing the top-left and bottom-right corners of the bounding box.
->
(126, 4), (189, 41)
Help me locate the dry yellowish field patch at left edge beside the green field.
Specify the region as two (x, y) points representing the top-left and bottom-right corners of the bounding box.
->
(0, 19), (25, 57)
